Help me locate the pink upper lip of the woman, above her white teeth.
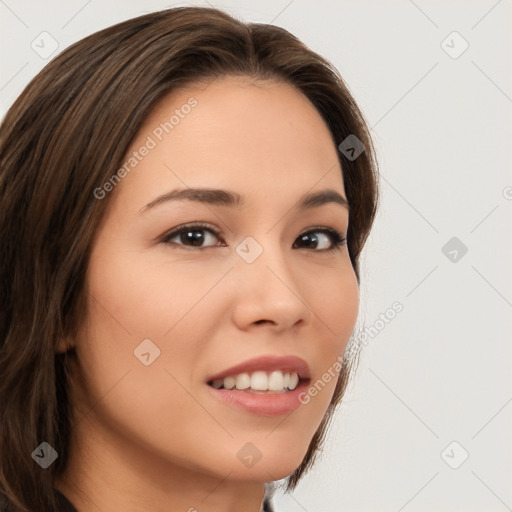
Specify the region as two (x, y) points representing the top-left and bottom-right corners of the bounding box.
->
(207, 355), (311, 382)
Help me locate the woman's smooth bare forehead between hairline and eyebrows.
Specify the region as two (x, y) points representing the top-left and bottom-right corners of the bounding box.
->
(110, 77), (344, 212)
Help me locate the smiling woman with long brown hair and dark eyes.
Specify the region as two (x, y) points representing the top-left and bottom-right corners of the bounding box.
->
(0, 7), (377, 512)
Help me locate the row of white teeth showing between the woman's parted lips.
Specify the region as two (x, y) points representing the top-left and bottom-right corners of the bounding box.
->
(212, 370), (299, 392)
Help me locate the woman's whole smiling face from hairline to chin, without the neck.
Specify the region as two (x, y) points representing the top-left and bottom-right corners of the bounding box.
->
(66, 77), (359, 481)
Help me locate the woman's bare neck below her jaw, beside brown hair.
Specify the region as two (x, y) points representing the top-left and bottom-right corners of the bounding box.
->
(55, 416), (265, 512)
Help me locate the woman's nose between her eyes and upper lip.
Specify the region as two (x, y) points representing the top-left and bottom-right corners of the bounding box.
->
(232, 237), (312, 333)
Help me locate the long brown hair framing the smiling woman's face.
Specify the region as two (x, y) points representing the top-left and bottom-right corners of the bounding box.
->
(0, 7), (378, 512)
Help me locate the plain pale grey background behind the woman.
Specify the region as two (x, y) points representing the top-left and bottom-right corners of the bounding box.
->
(0, 0), (512, 512)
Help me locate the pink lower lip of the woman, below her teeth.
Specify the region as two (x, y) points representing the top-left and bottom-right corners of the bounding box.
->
(207, 381), (307, 416)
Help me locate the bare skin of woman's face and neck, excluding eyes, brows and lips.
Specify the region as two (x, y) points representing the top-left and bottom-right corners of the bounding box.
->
(56, 77), (359, 512)
